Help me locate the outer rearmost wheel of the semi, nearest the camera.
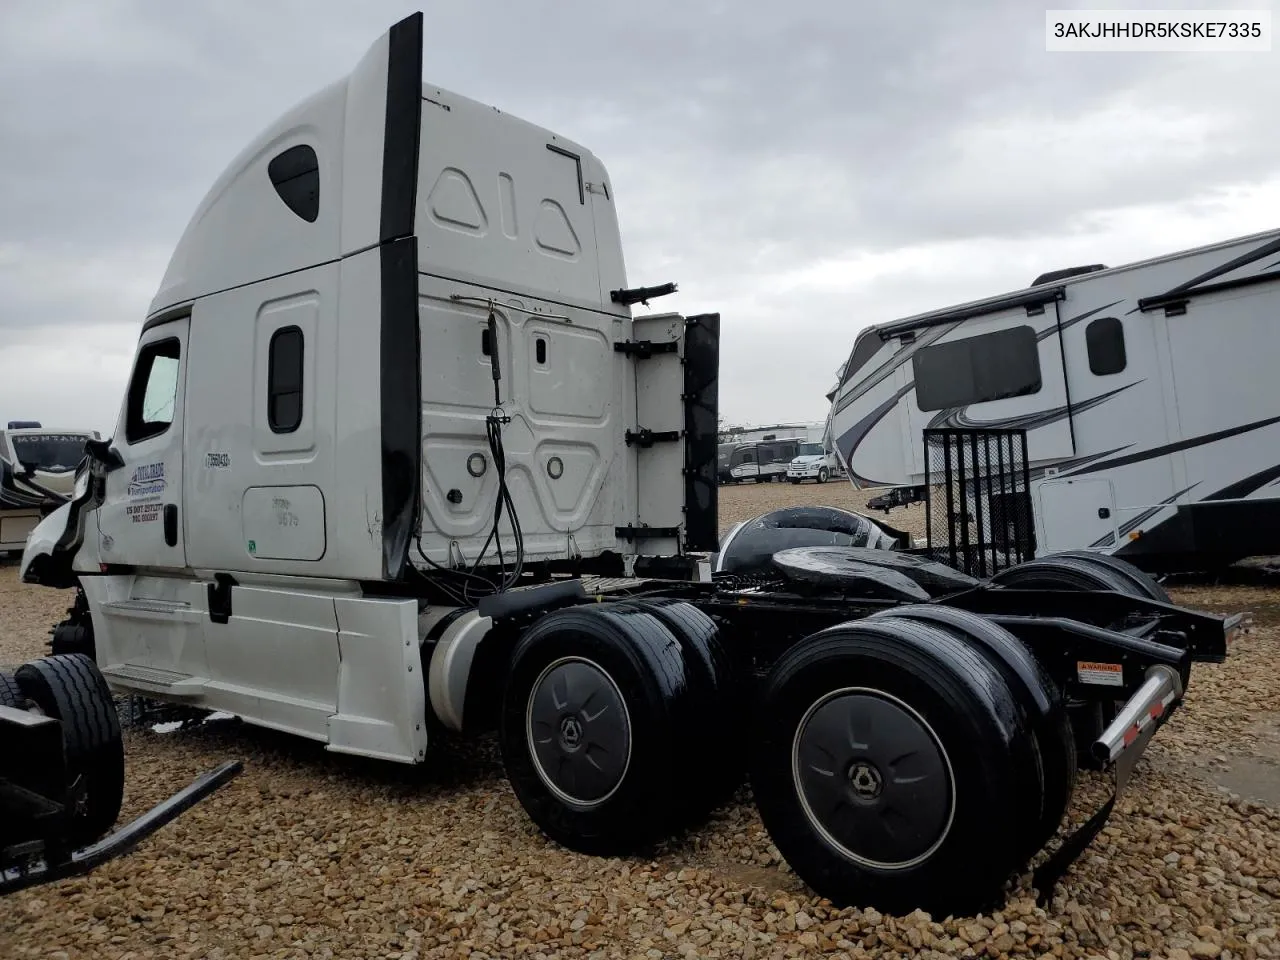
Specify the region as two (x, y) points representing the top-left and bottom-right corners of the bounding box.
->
(751, 620), (1041, 916)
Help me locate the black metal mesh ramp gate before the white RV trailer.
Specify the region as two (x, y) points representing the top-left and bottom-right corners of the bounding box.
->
(924, 428), (1036, 577)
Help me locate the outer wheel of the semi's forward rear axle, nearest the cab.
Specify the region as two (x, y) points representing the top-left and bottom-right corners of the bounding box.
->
(499, 604), (700, 856)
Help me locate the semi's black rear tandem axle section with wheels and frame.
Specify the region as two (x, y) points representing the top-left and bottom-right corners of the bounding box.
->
(468, 547), (1243, 915)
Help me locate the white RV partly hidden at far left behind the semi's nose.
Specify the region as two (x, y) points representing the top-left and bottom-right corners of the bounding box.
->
(0, 420), (99, 553)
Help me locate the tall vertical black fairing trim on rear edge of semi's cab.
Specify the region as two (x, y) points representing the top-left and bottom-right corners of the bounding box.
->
(379, 13), (422, 580)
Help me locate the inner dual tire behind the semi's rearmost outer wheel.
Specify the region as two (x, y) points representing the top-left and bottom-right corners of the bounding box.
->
(868, 604), (1078, 859)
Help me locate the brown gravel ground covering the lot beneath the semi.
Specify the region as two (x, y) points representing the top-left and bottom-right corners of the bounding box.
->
(0, 484), (1280, 960)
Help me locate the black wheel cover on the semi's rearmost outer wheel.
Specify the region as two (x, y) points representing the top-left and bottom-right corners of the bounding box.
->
(791, 687), (955, 870)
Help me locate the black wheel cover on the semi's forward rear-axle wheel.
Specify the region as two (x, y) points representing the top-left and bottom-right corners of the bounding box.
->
(525, 657), (631, 806)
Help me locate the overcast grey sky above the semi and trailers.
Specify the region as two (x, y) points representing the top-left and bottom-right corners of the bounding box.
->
(0, 0), (1280, 435)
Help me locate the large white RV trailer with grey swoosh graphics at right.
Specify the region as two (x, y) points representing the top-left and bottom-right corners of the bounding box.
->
(831, 230), (1280, 571)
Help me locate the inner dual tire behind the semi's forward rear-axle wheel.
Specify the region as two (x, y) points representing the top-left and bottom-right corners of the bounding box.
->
(618, 596), (746, 823)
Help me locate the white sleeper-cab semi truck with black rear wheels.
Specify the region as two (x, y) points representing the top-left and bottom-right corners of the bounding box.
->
(22, 14), (1239, 915)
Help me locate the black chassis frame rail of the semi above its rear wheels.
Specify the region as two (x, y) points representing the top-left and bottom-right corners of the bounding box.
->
(498, 575), (1249, 906)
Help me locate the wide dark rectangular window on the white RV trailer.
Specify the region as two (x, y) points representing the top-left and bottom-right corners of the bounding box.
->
(911, 325), (1041, 411)
